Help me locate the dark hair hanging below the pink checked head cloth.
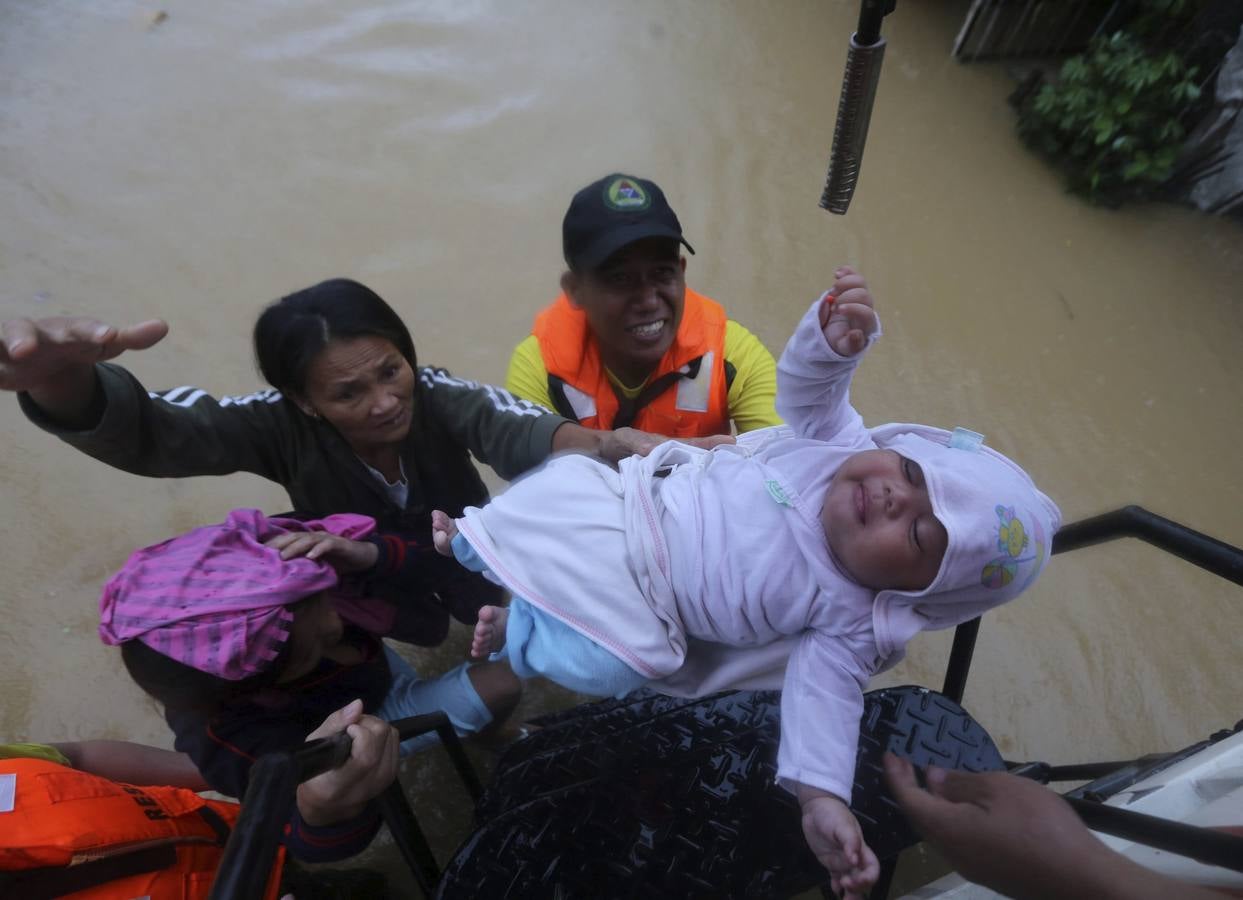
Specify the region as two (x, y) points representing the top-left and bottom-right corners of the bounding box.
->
(121, 640), (291, 714)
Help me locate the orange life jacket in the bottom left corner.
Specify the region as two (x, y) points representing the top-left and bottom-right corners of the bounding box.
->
(0, 758), (285, 900)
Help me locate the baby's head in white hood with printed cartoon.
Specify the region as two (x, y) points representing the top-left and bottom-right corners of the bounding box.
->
(820, 425), (1060, 643)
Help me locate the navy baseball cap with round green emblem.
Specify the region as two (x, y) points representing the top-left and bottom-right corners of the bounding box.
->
(561, 172), (695, 271)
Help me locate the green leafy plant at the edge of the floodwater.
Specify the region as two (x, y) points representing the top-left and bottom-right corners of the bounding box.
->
(1018, 31), (1199, 205)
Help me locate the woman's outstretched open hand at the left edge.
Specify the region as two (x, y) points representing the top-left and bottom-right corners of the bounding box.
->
(0, 316), (168, 390)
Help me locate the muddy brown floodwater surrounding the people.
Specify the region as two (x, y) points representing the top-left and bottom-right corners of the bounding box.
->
(0, 0), (1243, 885)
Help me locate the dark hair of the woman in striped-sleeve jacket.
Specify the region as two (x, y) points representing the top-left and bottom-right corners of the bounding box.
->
(255, 278), (418, 395)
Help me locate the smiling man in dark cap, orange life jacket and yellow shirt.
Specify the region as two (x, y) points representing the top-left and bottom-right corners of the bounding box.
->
(506, 173), (781, 438)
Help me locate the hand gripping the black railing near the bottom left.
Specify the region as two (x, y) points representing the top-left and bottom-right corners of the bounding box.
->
(297, 700), (398, 825)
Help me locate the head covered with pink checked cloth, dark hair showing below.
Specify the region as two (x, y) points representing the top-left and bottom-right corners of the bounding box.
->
(99, 510), (362, 709)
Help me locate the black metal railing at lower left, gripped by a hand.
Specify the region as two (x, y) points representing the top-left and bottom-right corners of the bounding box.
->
(210, 712), (481, 900)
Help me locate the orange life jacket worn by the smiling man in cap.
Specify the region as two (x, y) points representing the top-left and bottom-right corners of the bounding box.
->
(531, 287), (732, 438)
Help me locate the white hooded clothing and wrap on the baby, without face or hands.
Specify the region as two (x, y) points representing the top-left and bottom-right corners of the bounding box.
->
(459, 293), (1060, 797)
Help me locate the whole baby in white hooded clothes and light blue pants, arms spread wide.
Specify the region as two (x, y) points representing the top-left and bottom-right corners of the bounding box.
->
(433, 267), (1060, 896)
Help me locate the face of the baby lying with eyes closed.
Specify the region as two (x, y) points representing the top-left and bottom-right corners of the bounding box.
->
(820, 450), (950, 590)
